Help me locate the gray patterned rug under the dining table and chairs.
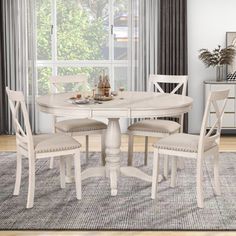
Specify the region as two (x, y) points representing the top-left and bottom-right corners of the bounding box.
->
(0, 153), (236, 230)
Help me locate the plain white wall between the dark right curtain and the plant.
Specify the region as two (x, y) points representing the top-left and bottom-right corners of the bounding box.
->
(187, 0), (236, 133)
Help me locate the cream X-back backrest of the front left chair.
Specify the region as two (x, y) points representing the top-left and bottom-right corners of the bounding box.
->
(6, 87), (34, 151)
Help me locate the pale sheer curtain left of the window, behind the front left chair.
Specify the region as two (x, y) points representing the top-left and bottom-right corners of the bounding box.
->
(1, 0), (37, 134)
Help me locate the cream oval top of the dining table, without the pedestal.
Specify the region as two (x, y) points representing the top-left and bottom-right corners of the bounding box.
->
(37, 91), (193, 118)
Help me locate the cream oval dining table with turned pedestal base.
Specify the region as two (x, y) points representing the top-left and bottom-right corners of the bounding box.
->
(37, 92), (193, 196)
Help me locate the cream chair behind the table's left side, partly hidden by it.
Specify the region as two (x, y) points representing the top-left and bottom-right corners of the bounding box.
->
(50, 74), (107, 170)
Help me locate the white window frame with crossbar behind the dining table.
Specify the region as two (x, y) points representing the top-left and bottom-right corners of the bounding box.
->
(36, 0), (132, 93)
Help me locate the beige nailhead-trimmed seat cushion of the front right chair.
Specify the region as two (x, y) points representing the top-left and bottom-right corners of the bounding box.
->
(153, 133), (217, 152)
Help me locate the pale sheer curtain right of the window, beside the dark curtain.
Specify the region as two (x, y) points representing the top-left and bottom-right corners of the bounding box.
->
(129, 0), (159, 91)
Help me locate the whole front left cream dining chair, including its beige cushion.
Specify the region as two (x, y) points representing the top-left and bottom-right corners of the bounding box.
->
(6, 88), (81, 208)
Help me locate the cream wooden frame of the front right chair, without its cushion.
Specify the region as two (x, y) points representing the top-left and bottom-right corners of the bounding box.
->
(151, 90), (229, 208)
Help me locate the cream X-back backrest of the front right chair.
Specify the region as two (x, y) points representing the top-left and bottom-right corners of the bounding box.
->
(198, 90), (229, 153)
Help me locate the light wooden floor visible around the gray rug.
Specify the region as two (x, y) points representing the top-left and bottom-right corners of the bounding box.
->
(0, 135), (236, 236)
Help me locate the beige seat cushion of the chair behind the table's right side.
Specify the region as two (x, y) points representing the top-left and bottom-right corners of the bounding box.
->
(128, 120), (180, 134)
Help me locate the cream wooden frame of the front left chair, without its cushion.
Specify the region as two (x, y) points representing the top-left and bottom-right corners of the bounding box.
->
(6, 88), (81, 208)
